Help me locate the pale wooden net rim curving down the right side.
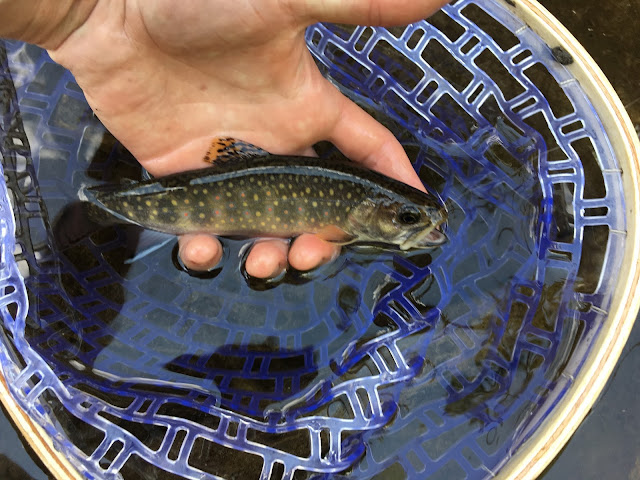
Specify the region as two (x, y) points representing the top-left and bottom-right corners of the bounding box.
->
(495, 0), (640, 480)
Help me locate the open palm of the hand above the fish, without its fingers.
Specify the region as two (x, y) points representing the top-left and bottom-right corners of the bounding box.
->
(52, 0), (341, 169)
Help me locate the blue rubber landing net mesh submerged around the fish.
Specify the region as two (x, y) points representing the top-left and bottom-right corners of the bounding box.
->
(0, 0), (626, 480)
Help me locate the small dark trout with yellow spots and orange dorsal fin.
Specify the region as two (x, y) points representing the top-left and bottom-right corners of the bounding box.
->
(70, 138), (447, 250)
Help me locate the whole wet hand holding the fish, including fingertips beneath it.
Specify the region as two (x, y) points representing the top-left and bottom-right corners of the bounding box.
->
(40, 0), (446, 278)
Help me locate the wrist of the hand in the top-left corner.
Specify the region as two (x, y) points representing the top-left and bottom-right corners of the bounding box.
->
(0, 0), (97, 49)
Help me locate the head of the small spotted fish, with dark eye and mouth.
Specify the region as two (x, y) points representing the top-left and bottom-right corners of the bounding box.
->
(349, 199), (447, 250)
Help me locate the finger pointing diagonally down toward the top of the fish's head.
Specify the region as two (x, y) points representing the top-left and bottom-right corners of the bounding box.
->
(328, 93), (425, 191)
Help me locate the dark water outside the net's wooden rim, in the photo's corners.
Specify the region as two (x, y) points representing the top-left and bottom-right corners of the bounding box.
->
(0, 0), (640, 480)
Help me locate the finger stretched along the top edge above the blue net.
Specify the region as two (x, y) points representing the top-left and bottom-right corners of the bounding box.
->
(289, 0), (449, 26)
